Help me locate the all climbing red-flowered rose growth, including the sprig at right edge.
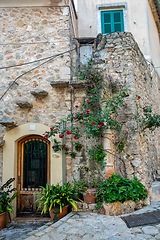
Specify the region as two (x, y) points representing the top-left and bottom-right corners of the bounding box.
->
(44, 61), (160, 179)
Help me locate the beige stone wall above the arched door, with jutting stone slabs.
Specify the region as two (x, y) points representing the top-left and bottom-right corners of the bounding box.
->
(0, 6), (76, 183)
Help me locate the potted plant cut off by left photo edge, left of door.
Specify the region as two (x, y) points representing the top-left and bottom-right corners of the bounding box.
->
(0, 178), (17, 229)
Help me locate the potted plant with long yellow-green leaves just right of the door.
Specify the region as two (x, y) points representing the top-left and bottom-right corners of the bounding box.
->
(37, 183), (78, 221)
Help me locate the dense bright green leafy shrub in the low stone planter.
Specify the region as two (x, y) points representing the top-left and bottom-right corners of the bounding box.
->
(97, 174), (147, 203)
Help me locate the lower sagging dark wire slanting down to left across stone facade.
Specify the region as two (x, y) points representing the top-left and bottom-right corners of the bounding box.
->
(0, 39), (95, 100)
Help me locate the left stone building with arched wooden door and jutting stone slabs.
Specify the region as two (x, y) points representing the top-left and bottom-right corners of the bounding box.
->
(0, 0), (77, 216)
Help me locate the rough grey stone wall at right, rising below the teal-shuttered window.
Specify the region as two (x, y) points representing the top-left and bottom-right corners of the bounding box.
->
(93, 33), (160, 186)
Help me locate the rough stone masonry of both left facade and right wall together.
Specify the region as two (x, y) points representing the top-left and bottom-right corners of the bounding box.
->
(0, 2), (159, 190)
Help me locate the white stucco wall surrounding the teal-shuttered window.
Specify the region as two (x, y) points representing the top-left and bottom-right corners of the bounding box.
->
(77, 0), (160, 74)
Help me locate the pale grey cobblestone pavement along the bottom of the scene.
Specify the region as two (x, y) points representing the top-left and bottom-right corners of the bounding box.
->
(0, 199), (160, 240)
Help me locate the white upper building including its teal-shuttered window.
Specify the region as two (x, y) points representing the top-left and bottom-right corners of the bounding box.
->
(77, 0), (160, 74)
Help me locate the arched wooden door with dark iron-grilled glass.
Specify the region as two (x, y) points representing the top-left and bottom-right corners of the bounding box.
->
(17, 135), (50, 216)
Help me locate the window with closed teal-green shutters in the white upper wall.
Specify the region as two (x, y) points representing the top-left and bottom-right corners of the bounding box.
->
(101, 10), (124, 34)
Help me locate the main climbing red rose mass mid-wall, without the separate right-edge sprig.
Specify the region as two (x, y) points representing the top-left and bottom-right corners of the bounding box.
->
(44, 61), (129, 170)
